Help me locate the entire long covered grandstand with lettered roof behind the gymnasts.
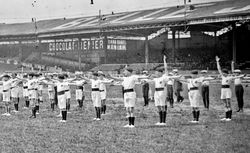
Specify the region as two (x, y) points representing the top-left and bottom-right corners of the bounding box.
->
(0, 0), (250, 73)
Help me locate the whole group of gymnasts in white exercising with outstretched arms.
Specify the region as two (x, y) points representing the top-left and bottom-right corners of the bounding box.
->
(0, 56), (248, 128)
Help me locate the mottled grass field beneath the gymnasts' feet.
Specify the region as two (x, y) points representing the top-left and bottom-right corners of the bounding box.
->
(0, 85), (250, 153)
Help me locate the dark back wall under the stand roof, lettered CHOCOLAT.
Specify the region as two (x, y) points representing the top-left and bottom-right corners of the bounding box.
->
(0, 29), (232, 67)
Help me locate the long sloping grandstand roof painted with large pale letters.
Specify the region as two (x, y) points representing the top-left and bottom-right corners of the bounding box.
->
(0, 0), (250, 37)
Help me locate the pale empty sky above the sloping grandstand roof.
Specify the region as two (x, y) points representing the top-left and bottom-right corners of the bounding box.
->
(0, 0), (226, 23)
